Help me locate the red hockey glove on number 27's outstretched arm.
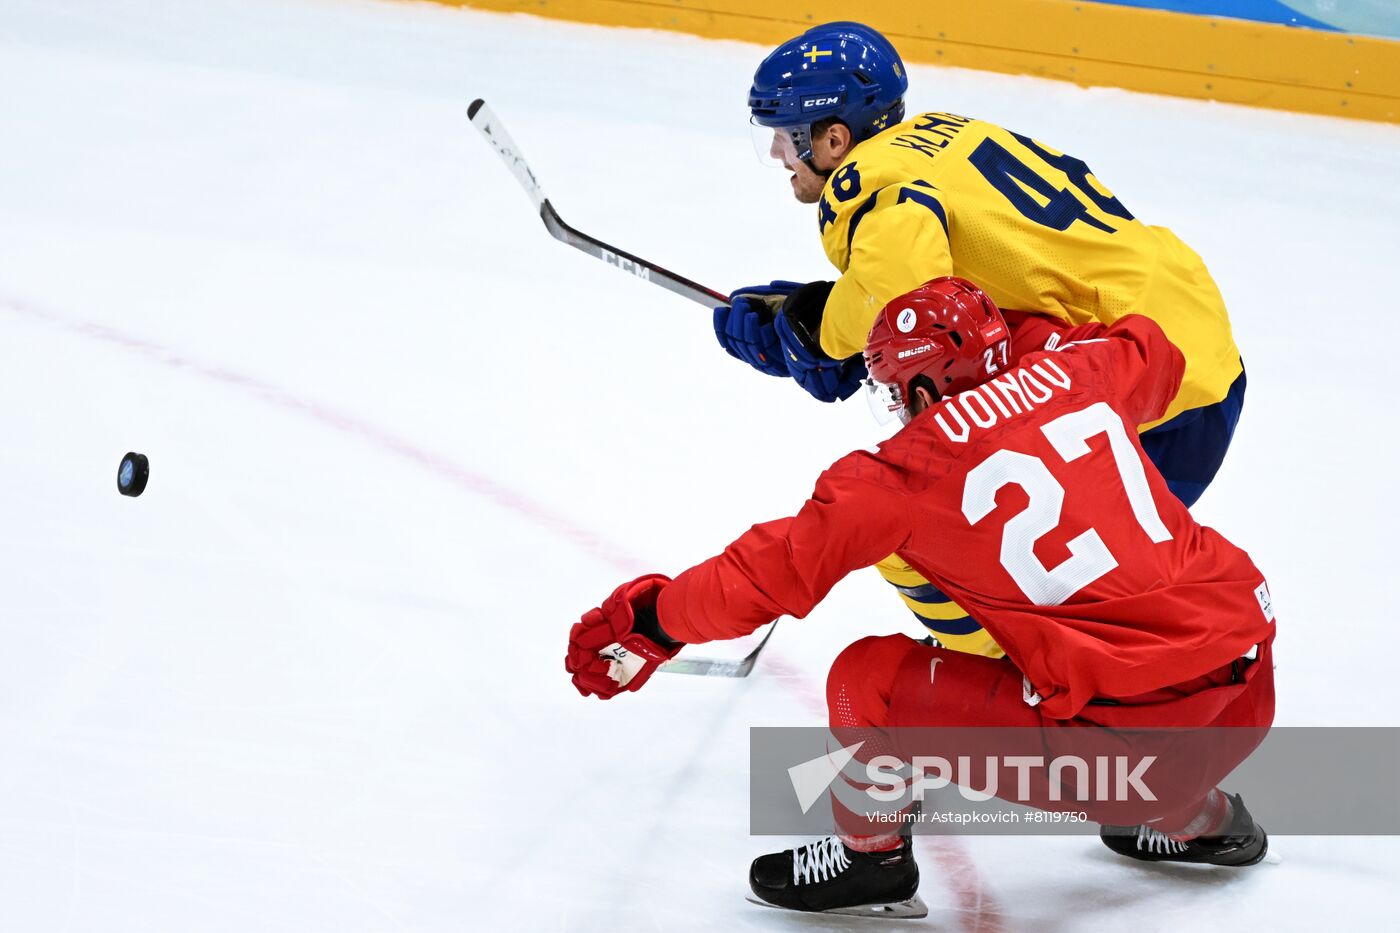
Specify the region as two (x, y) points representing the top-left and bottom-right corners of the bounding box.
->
(564, 573), (683, 699)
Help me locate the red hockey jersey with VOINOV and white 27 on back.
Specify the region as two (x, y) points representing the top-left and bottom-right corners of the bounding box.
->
(658, 315), (1274, 719)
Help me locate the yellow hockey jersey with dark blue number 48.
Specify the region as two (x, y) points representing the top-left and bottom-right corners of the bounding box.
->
(818, 113), (1240, 430)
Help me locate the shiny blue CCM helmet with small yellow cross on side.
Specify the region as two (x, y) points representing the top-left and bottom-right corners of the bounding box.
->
(749, 22), (909, 171)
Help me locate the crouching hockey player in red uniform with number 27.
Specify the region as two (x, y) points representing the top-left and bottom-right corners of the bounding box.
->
(566, 277), (1274, 911)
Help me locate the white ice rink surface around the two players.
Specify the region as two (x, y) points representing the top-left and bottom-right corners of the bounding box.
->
(0, 0), (1400, 933)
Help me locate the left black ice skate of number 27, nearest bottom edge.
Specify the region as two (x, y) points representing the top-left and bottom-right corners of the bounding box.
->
(749, 836), (928, 919)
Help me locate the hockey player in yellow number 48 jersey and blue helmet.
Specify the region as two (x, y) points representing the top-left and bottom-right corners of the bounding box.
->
(715, 22), (1245, 657)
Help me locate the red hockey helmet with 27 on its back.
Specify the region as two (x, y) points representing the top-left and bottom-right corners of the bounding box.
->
(865, 276), (1011, 424)
